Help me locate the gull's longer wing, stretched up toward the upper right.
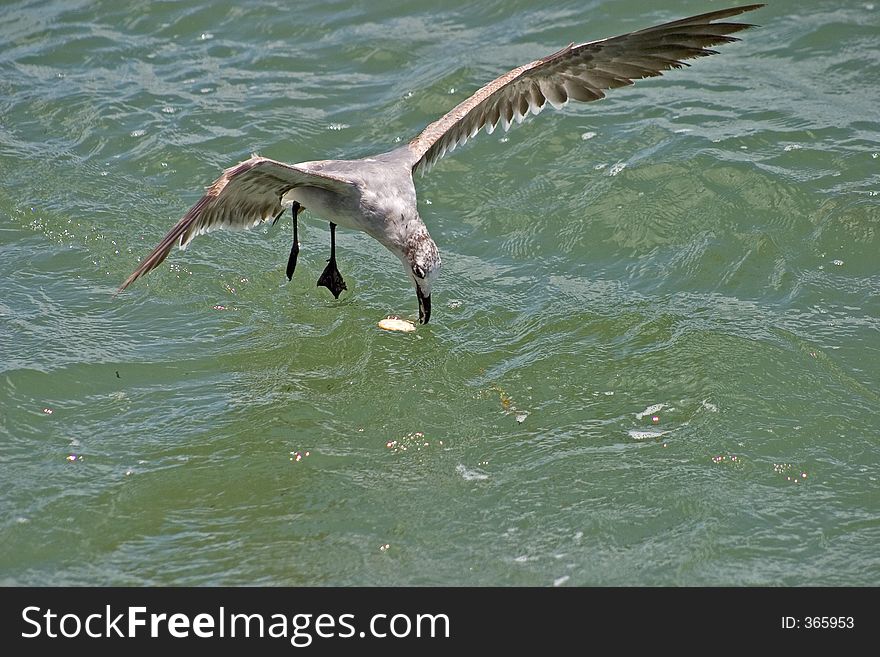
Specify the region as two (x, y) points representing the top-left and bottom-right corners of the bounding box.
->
(409, 4), (764, 172)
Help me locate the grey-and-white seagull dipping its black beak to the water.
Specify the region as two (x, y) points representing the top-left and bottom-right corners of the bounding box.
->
(117, 4), (764, 324)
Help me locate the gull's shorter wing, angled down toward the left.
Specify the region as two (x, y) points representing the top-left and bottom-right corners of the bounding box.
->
(117, 155), (356, 293)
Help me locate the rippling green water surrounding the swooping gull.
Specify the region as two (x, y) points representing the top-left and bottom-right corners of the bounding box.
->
(0, 0), (880, 586)
